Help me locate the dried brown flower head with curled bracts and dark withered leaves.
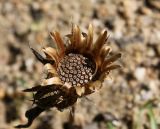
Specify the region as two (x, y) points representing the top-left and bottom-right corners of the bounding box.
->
(16, 25), (121, 128)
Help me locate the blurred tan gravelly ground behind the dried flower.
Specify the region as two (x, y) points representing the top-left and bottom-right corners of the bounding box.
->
(0, 0), (160, 129)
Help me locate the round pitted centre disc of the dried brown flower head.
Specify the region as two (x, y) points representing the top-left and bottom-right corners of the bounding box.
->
(57, 53), (95, 86)
